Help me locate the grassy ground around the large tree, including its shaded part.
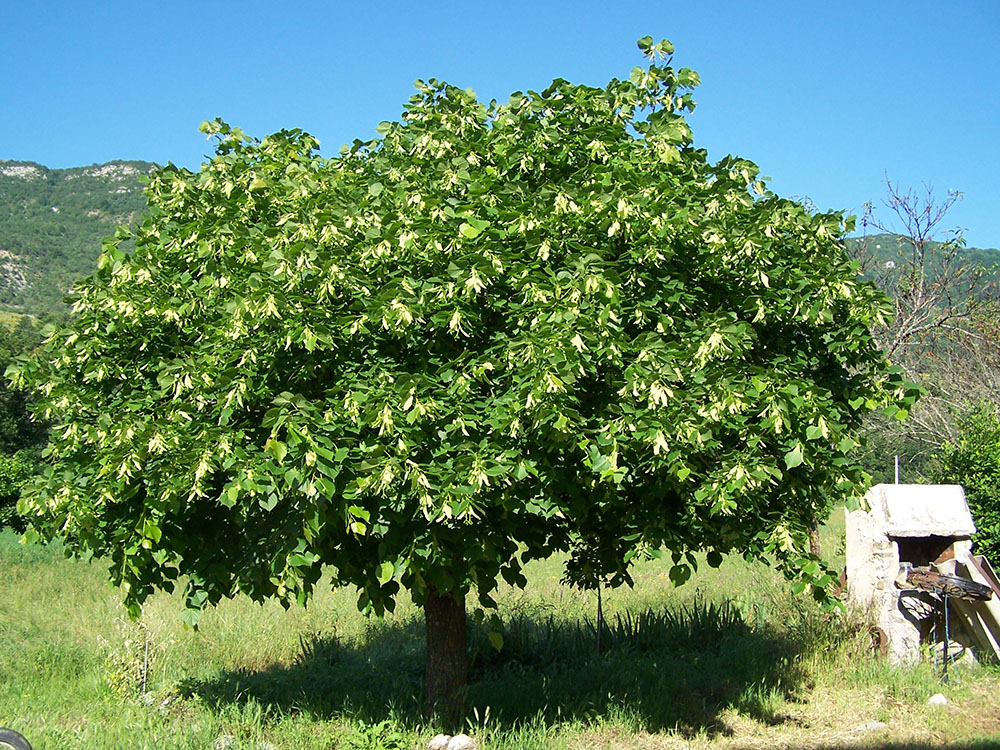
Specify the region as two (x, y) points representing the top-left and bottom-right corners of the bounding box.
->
(0, 523), (1000, 750)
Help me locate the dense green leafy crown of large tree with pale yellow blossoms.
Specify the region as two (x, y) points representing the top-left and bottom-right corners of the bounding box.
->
(14, 38), (913, 622)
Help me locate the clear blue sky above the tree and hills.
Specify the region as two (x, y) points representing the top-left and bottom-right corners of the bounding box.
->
(0, 0), (1000, 248)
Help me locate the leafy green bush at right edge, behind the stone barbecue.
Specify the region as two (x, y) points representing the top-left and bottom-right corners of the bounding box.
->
(936, 404), (1000, 560)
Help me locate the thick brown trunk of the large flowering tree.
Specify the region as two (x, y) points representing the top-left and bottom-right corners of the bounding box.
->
(424, 588), (468, 721)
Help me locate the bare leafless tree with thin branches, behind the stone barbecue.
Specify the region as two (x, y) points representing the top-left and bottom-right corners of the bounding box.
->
(854, 179), (1000, 468)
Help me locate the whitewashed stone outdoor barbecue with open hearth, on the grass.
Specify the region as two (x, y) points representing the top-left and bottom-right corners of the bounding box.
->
(847, 484), (976, 664)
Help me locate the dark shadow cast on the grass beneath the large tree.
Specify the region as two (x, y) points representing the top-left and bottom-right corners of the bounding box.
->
(180, 602), (818, 735)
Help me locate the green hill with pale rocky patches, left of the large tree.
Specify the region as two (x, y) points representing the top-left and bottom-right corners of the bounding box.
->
(0, 160), (155, 316)
